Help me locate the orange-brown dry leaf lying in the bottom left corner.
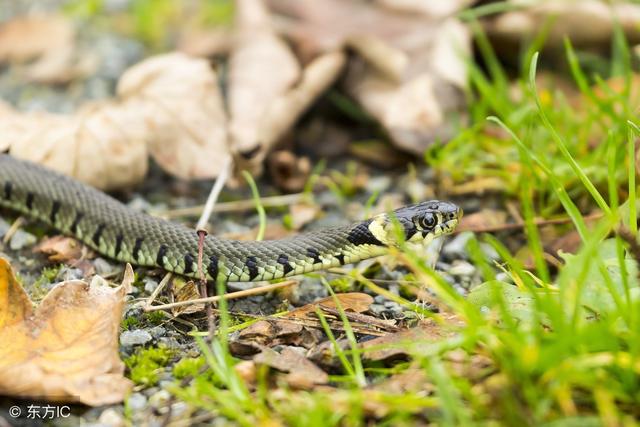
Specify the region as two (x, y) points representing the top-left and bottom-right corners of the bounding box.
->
(0, 259), (132, 406)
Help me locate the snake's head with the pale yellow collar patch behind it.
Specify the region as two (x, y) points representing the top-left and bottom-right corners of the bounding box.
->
(369, 200), (462, 246)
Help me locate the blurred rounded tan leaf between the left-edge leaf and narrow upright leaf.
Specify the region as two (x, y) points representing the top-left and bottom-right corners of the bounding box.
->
(117, 53), (228, 179)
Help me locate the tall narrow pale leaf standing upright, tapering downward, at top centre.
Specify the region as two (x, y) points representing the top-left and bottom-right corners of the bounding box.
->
(229, 0), (300, 163)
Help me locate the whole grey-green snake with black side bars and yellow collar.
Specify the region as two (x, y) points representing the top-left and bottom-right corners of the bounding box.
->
(0, 154), (462, 282)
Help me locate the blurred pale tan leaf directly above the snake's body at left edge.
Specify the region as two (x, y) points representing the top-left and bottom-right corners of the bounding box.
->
(5, 102), (148, 190)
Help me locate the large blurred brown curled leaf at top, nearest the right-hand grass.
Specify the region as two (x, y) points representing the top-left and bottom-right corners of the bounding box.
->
(269, 0), (470, 154)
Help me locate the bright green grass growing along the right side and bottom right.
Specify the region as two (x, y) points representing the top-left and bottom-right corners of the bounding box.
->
(165, 15), (640, 426)
